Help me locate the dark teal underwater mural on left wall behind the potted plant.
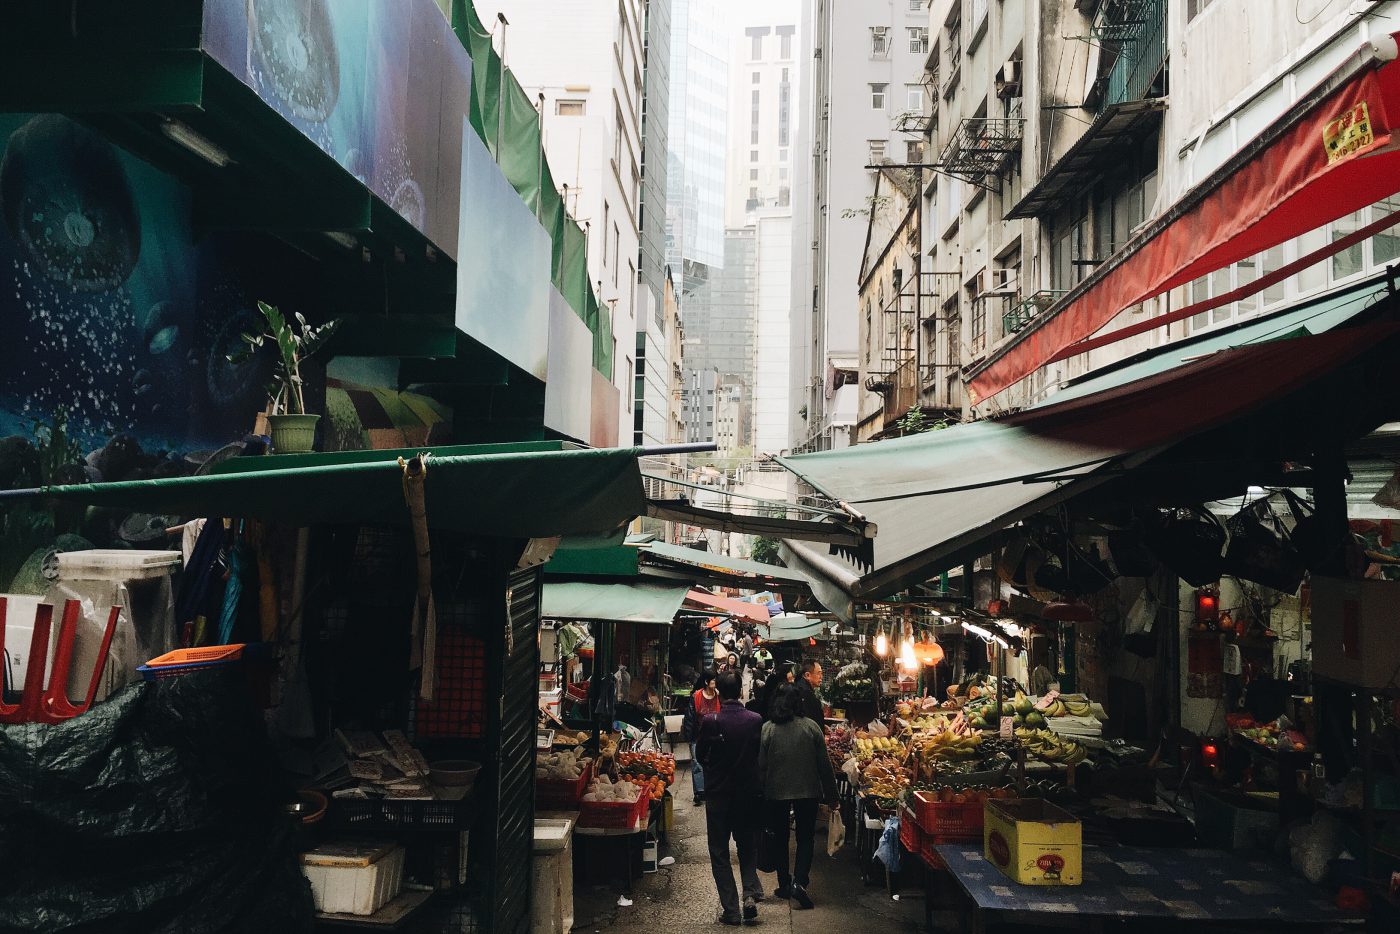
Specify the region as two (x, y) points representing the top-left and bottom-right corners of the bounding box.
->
(0, 113), (323, 590)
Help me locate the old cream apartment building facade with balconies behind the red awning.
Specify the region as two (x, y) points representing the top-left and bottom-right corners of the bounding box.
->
(862, 0), (1400, 434)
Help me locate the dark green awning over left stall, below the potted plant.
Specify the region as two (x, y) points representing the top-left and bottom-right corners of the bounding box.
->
(0, 442), (645, 538)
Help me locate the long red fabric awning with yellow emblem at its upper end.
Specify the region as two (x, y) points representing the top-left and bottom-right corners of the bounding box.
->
(969, 37), (1400, 403)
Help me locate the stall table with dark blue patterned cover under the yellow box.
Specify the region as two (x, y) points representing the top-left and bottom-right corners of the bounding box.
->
(928, 843), (1361, 934)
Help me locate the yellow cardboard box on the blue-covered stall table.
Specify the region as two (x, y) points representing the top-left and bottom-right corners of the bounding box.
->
(981, 798), (1084, 885)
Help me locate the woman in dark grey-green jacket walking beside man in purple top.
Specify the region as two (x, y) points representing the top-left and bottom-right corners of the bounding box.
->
(759, 685), (836, 909)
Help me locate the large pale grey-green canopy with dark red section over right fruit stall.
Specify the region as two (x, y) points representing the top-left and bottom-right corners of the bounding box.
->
(781, 323), (1400, 598)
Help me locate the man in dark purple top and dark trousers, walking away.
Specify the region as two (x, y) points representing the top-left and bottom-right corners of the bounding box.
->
(696, 672), (763, 926)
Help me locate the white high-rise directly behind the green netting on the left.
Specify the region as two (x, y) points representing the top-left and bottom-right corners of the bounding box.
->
(496, 0), (645, 442)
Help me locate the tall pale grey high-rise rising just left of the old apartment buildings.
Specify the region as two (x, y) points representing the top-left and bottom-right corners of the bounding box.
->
(791, 0), (935, 451)
